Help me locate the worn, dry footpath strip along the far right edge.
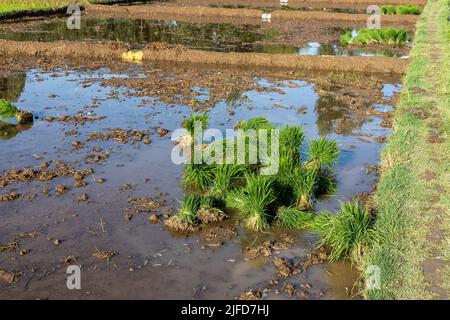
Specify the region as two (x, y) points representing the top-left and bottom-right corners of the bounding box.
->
(422, 0), (450, 299)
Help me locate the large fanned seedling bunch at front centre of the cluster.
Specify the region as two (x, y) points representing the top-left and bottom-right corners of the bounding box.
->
(228, 174), (276, 231)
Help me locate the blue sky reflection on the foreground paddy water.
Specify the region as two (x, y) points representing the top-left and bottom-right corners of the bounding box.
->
(0, 70), (399, 209)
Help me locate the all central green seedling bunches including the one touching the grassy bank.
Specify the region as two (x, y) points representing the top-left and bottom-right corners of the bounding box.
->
(166, 114), (372, 260)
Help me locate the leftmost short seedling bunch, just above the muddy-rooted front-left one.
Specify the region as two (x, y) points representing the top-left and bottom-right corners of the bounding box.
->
(182, 164), (214, 192)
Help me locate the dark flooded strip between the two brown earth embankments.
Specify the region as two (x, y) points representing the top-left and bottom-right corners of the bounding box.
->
(0, 17), (409, 57)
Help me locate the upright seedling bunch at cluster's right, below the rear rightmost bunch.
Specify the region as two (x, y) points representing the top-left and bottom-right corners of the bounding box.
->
(288, 168), (317, 210)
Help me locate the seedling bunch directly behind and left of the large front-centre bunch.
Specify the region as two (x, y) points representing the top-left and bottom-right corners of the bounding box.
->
(209, 164), (248, 199)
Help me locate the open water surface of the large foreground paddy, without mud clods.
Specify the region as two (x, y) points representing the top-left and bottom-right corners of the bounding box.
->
(0, 66), (399, 299)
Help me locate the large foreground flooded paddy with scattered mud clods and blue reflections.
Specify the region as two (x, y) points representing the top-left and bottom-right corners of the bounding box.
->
(0, 61), (399, 299)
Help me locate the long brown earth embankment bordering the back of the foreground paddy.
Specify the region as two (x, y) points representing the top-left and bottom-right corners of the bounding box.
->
(0, 40), (407, 74)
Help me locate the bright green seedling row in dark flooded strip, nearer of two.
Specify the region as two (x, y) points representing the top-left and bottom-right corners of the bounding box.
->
(341, 28), (410, 46)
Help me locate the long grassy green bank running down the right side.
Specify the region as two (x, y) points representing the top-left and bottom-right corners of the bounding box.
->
(361, 0), (450, 300)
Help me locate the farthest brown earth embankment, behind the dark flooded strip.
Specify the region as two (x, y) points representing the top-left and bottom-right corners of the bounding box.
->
(87, 5), (418, 27)
